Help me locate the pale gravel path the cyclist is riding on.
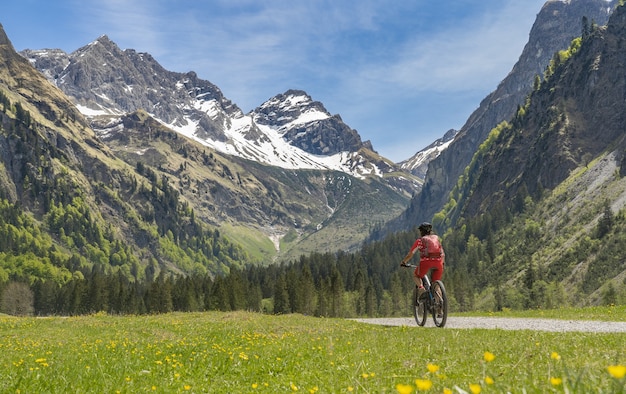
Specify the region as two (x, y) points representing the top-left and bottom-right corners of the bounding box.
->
(353, 316), (626, 332)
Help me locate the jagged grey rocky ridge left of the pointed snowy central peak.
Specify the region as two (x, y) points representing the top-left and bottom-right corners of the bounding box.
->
(22, 36), (242, 139)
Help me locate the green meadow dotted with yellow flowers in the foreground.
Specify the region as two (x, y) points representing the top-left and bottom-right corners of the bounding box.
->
(0, 308), (626, 393)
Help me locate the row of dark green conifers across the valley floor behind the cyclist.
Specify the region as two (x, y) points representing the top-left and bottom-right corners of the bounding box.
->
(0, 188), (626, 317)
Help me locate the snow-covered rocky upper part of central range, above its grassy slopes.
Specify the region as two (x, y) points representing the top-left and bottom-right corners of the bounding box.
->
(22, 36), (421, 194)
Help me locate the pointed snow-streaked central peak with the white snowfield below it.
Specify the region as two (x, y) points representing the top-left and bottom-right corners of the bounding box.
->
(167, 90), (382, 177)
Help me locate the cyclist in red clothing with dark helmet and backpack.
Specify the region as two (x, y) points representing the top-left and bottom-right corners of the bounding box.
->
(400, 222), (445, 294)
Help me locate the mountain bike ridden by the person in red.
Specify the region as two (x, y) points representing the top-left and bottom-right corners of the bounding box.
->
(402, 264), (448, 328)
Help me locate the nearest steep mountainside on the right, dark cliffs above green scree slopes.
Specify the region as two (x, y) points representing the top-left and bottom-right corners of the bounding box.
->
(435, 1), (626, 308)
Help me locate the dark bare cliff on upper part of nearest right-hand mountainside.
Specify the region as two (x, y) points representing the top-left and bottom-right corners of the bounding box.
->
(463, 6), (626, 217)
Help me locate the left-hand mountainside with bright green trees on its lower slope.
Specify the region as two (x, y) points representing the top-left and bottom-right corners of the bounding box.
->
(0, 26), (251, 284)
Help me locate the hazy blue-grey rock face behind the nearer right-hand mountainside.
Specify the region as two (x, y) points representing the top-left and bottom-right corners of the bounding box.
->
(398, 0), (615, 228)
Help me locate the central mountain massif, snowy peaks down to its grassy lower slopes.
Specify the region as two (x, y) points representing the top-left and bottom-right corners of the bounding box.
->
(21, 36), (421, 262)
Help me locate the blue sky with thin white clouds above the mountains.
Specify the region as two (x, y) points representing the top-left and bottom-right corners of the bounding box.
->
(0, 0), (545, 162)
